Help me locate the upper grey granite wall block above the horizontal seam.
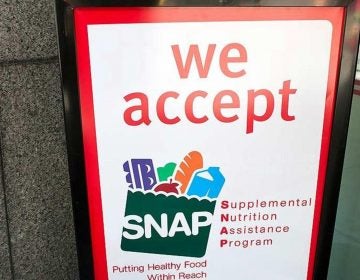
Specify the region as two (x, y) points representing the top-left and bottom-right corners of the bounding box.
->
(0, 0), (57, 61)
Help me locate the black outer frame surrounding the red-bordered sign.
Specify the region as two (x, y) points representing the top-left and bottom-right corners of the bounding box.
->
(56, 0), (360, 280)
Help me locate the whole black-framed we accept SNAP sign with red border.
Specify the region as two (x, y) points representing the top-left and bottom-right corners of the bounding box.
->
(57, 1), (358, 280)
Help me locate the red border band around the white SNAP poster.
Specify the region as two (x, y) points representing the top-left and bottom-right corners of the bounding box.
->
(74, 7), (345, 280)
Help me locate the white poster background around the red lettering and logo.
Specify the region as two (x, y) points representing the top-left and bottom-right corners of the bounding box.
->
(88, 20), (332, 280)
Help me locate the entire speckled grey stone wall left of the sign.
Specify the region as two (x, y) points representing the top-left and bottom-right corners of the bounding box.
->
(0, 0), (78, 280)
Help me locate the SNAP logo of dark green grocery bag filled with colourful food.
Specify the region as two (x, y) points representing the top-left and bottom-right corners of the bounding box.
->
(121, 151), (225, 257)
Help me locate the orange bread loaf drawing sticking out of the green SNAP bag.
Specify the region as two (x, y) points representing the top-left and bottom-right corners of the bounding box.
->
(175, 151), (203, 193)
